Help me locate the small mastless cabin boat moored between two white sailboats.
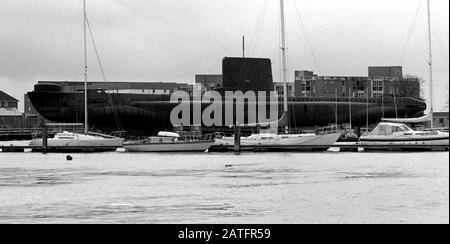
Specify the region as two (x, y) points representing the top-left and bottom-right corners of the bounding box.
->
(123, 131), (214, 152)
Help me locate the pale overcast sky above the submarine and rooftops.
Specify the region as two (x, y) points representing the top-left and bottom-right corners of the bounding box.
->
(0, 0), (449, 110)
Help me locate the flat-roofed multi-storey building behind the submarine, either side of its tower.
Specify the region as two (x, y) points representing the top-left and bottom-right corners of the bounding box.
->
(195, 66), (420, 99)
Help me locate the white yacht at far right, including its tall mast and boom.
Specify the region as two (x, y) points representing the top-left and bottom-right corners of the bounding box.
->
(360, 0), (449, 149)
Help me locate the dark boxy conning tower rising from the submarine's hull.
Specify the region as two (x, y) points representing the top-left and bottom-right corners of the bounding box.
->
(222, 57), (274, 92)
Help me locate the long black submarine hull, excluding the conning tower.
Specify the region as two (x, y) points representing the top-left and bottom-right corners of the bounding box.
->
(28, 91), (426, 136)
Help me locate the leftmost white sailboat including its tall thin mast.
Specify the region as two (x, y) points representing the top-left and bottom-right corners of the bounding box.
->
(29, 0), (123, 152)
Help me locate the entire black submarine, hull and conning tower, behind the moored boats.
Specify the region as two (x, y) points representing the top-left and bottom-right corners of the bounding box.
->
(27, 57), (426, 137)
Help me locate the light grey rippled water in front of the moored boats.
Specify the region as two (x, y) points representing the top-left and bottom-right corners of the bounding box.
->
(0, 152), (449, 224)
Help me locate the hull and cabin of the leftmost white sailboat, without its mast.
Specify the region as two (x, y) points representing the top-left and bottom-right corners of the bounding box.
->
(29, 131), (123, 151)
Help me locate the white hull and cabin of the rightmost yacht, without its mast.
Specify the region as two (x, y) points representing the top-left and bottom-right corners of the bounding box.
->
(360, 122), (449, 147)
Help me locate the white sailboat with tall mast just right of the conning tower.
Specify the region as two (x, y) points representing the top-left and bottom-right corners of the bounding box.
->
(215, 0), (341, 146)
